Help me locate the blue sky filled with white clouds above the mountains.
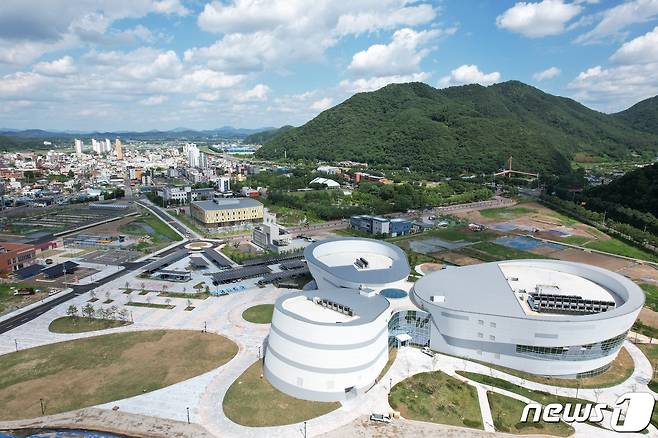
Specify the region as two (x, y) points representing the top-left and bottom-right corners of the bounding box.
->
(0, 0), (658, 130)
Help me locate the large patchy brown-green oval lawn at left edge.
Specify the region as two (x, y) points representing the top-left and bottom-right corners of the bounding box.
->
(0, 330), (238, 420)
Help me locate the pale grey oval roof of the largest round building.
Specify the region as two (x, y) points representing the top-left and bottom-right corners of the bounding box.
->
(412, 259), (644, 321)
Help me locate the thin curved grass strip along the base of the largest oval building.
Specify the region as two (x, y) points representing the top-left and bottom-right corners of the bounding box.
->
(488, 348), (635, 388)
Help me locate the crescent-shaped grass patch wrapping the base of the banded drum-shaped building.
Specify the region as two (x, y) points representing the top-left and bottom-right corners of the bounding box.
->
(222, 360), (340, 427)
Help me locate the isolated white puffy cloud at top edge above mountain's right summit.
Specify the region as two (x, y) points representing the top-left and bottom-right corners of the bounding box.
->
(496, 0), (583, 38)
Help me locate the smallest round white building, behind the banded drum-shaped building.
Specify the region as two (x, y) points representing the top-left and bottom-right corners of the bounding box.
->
(304, 238), (409, 292)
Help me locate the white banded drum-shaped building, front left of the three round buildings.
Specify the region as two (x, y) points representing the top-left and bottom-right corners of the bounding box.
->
(264, 288), (390, 401)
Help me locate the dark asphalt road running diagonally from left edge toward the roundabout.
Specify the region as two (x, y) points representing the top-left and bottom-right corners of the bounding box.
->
(0, 242), (187, 334)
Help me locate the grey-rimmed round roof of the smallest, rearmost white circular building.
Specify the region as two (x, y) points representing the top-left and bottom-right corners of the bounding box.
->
(304, 237), (410, 284)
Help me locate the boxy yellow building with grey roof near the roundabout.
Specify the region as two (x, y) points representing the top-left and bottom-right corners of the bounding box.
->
(190, 198), (263, 227)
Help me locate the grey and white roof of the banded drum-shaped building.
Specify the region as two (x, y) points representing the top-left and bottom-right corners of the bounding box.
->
(274, 288), (390, 325)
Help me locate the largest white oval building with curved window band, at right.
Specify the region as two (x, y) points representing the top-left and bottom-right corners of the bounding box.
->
(411, 260), (644, 377)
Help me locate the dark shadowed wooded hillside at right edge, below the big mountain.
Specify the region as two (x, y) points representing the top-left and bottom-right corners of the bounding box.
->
(587, 163), (658, 216)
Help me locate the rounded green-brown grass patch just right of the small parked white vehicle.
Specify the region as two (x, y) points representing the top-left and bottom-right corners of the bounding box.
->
(388, 371), (482, 429)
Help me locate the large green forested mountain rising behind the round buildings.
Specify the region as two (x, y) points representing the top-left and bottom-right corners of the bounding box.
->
(252, 81), (658, 175)
